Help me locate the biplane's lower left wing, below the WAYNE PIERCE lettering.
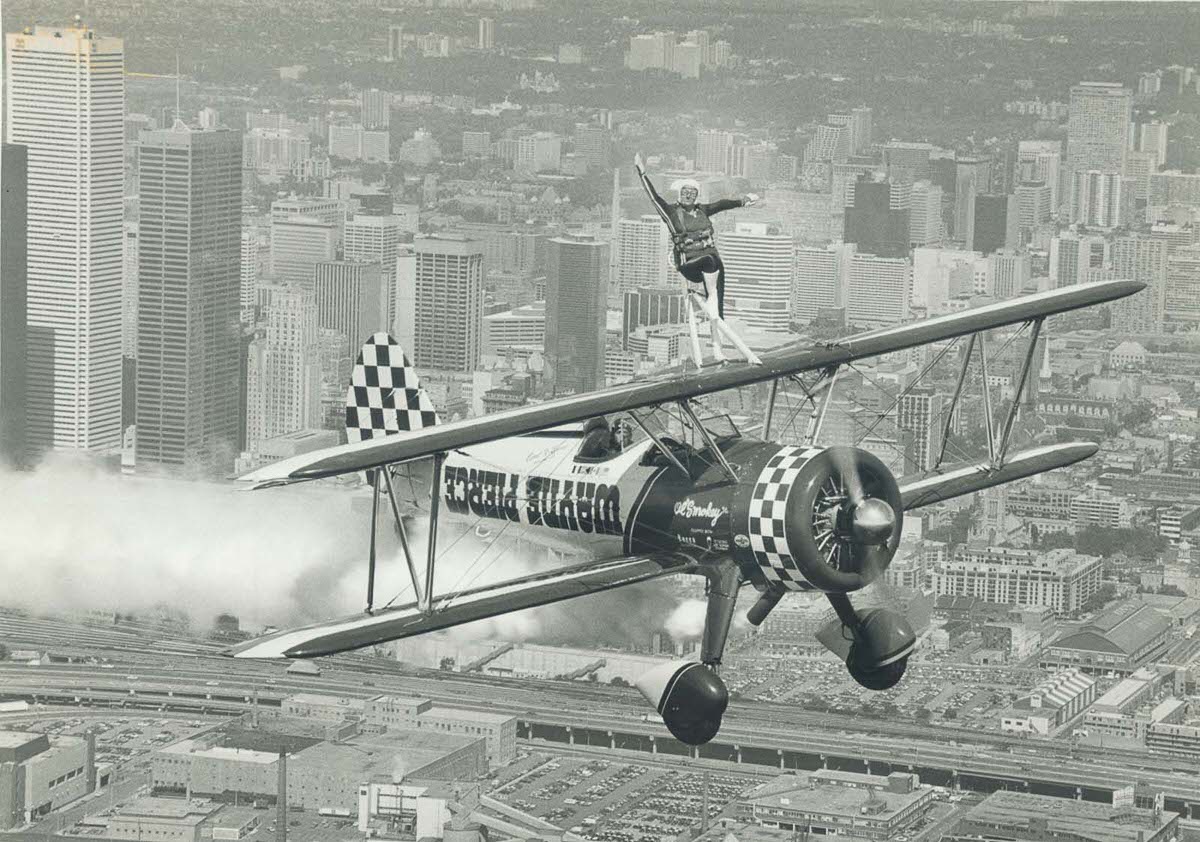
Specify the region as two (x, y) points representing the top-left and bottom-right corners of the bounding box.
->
(226, 553), (696, 658)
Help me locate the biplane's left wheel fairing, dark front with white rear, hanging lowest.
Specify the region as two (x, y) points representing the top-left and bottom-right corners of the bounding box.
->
(634, 661), (730, 746)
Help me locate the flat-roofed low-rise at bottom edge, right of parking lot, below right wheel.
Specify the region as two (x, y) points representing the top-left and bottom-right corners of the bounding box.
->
(734, 769), (934, 841)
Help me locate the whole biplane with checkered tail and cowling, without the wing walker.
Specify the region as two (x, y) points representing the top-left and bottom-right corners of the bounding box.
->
(228, 281), (1145, 745)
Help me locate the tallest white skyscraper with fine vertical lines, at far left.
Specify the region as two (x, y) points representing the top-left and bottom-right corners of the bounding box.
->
(5, 24), (125, 450)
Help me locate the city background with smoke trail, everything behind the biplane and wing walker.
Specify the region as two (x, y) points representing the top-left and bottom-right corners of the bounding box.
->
(0, 0), (1200, 842)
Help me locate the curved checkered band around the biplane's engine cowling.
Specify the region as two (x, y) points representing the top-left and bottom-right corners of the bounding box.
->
(748, 446), (821, 590)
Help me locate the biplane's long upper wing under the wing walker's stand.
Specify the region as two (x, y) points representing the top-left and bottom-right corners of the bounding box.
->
(242, 281), (1146, 487)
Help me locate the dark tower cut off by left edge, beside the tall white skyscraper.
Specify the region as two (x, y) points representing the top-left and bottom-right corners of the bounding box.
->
(0, 143), (29, 468)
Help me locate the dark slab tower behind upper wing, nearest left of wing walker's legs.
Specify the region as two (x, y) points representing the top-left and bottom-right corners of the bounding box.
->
(546, 236), (608, 395)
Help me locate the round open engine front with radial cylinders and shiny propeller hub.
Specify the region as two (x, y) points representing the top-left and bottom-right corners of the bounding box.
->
(786, 447), (904, 594)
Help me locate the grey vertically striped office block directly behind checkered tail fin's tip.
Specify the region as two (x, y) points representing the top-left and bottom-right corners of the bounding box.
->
(313, 257), (384, 360)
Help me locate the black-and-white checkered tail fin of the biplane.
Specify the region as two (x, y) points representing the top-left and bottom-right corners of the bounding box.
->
(346, 333), (438, 441)
